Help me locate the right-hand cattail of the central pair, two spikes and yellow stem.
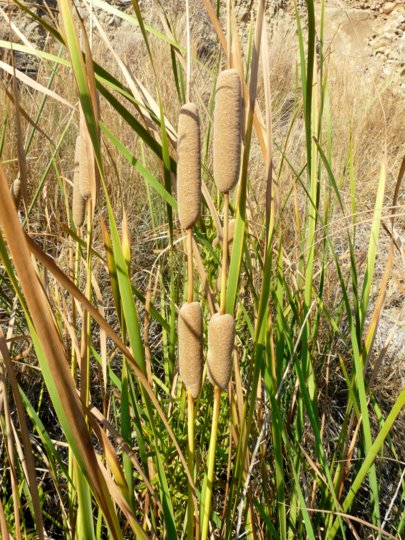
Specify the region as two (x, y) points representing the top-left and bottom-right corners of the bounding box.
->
(201, 69), (242, 540)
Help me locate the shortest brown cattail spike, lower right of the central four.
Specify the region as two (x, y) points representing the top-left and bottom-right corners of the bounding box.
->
(208, 313), (235, 390)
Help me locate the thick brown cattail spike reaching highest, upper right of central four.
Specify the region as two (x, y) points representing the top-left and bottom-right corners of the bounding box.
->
(214, 69), (242, 193)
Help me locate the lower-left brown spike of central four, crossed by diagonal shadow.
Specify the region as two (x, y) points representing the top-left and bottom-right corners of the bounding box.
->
(178, 302), (202, 399)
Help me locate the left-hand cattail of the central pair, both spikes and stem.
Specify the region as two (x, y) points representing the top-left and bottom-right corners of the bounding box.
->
(177, 96), (202, 539)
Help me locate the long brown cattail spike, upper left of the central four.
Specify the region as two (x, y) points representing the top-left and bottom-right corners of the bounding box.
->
(177, 103), (201, 230)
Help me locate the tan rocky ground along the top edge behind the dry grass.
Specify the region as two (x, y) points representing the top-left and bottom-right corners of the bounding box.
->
(0, 0), (405, 96)
